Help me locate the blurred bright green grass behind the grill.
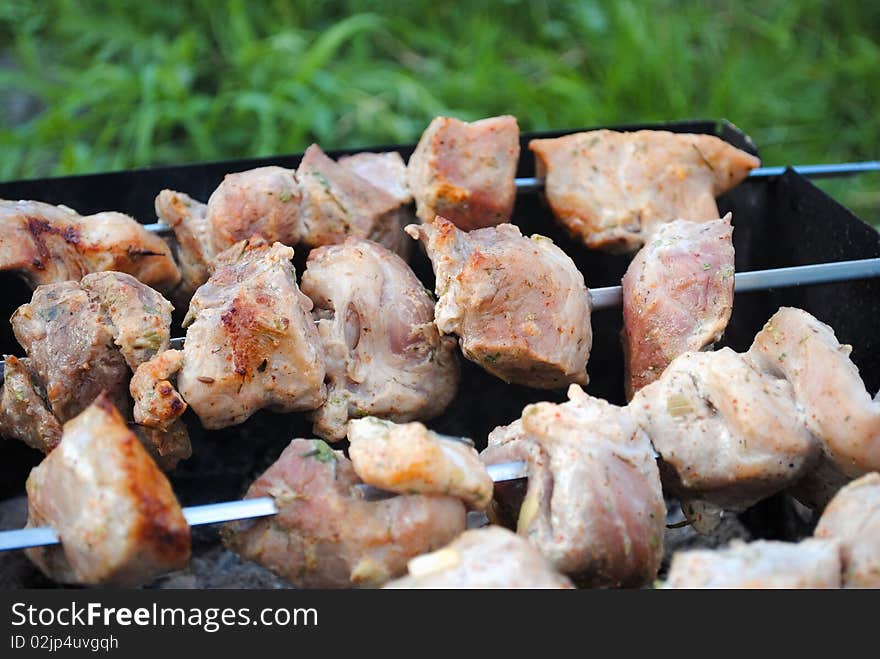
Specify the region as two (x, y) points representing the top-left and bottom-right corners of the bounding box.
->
(0, 0), (880, 222)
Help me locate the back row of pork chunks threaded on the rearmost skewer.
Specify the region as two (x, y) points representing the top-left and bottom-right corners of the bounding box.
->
(0, 116), (757, 306)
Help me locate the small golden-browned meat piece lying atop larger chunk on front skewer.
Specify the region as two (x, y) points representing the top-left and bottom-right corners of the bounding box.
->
(348, 417), (495, 510)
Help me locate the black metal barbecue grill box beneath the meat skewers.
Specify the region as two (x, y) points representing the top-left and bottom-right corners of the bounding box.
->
(0, 121), (880, 587)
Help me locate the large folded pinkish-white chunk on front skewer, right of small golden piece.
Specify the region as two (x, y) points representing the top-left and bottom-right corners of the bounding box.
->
(481, 385), (666, 586)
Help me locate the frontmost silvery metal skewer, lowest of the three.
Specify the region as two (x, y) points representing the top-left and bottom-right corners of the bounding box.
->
(0, 462), (526, 551)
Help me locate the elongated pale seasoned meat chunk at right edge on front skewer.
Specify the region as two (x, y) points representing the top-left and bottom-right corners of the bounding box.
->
(748, 307), (880, 477)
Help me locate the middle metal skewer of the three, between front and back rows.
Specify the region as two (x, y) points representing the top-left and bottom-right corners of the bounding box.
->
(6, 258), (880, 375)
